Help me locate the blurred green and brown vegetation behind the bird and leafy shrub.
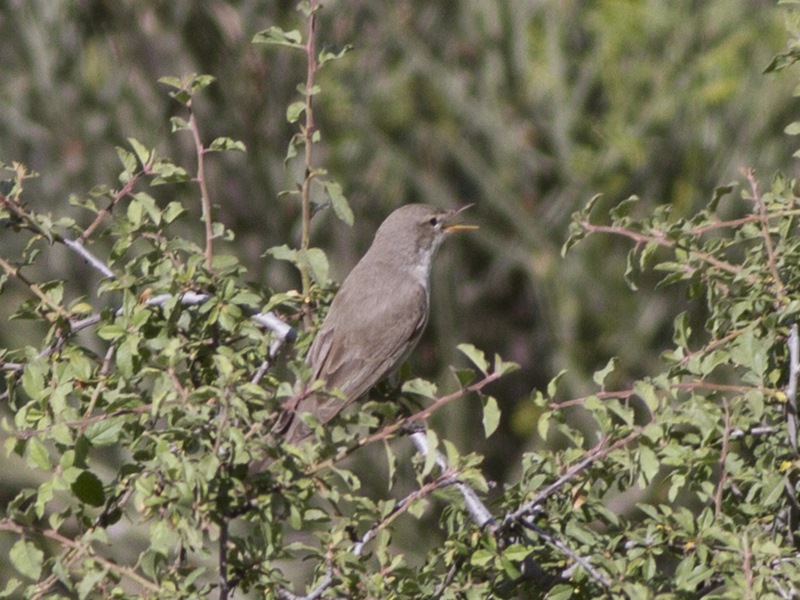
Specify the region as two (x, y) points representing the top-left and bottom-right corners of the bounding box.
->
(0, 0), (796, 488)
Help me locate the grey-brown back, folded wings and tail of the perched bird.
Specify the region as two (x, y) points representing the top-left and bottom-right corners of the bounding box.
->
(286, 265), (428, 441)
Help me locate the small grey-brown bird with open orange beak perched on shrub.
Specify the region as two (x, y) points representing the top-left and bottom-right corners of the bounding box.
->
(285, 204), (477, 444)
